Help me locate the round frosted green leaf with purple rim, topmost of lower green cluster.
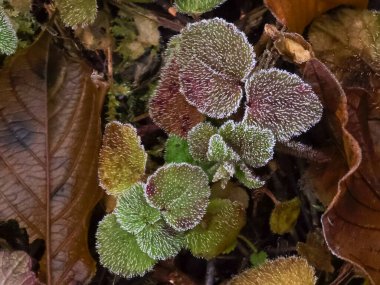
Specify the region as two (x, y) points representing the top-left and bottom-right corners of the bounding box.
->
(145, 163), (210, 231)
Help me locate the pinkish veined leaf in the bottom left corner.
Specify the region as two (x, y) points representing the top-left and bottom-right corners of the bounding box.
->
(0, 250), (42, 285)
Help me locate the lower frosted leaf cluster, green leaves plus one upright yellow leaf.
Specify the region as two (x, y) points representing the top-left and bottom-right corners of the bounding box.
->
(96, 122), (245, 277)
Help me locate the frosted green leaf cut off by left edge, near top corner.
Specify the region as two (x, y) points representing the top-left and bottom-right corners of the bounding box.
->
(0, 6), (17, 55)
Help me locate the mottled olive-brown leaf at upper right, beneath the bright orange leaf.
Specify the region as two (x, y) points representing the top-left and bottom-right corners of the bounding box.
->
(309, 9), (380, 88)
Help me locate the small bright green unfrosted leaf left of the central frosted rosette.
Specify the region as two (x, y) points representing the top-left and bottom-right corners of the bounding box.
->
(164, 135), (193, 163)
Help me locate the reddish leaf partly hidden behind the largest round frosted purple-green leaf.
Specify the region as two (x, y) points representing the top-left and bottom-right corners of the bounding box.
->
(149, 58), (204, 137)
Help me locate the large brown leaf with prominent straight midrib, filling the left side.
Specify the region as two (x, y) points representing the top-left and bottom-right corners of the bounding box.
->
(0, 33), (104, 284)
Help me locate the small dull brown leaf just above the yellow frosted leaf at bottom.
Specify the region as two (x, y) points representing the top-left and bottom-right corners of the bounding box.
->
(297, 231), (334, 273)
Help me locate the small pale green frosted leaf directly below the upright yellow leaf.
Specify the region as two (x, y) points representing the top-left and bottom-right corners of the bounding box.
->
(115, 183), (161, 234)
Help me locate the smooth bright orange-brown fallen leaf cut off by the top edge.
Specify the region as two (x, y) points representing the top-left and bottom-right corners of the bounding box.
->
(264, 0), (368, 34)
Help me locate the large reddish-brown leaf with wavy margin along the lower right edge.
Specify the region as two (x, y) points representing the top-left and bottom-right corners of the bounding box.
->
(322, 88), (380, 284)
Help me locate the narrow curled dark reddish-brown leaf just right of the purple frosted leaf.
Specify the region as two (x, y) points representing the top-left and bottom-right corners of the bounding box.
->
(303, 59), (361, 206)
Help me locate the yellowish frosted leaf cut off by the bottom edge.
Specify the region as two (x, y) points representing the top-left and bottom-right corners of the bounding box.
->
(229, 256), (317, 285)
